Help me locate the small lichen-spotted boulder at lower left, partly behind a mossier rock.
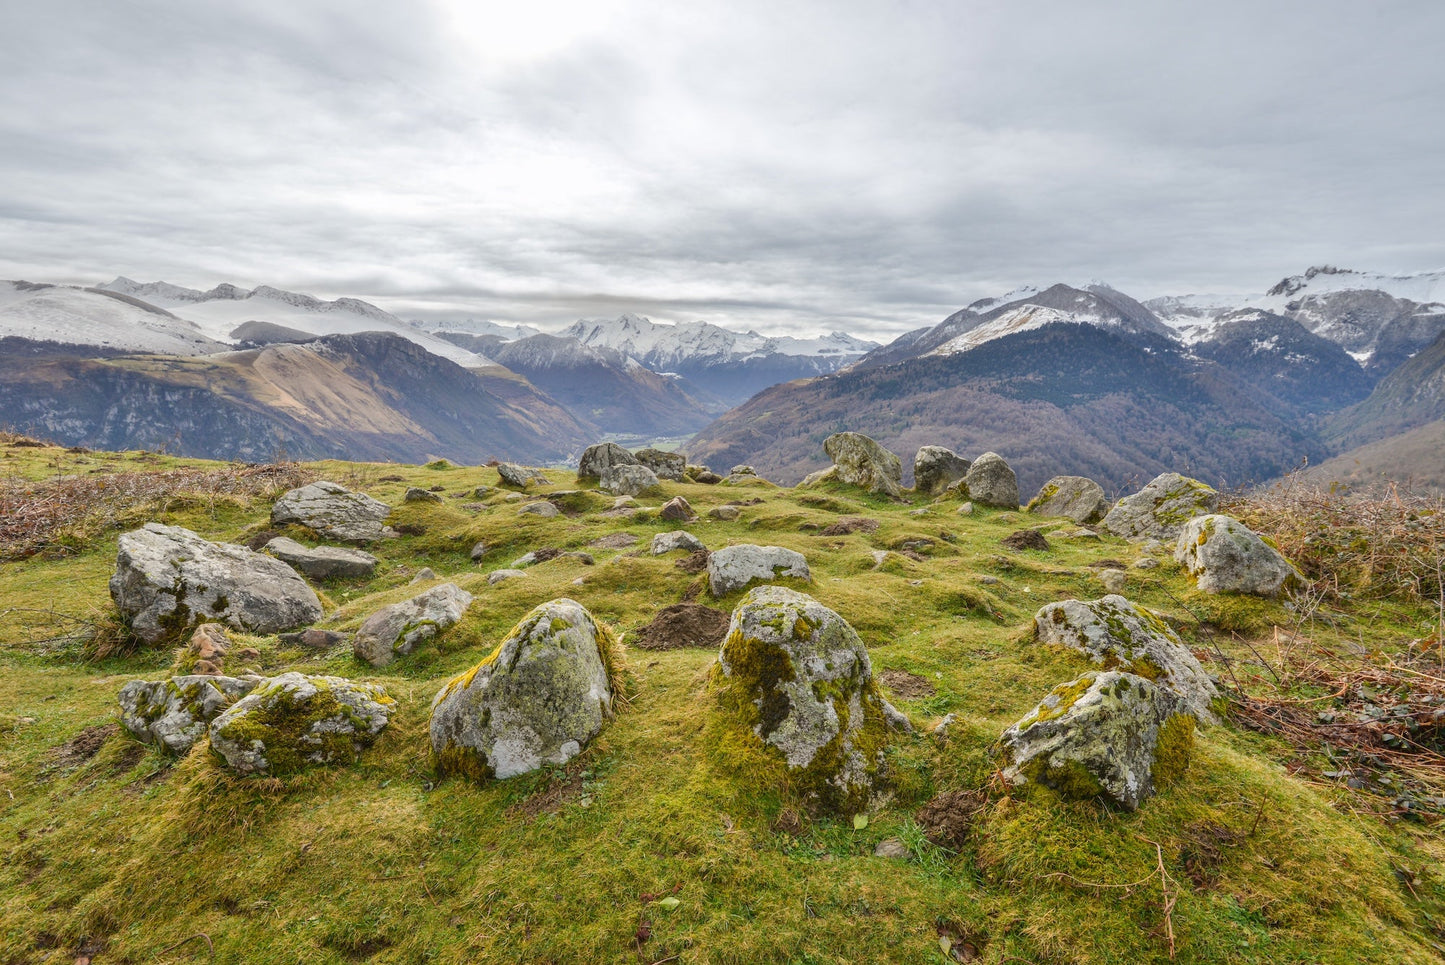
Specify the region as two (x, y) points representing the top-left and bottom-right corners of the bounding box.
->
(120, 675), (260, 754)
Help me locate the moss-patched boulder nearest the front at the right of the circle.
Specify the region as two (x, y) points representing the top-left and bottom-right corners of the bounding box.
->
(998, 670), (1194, 810)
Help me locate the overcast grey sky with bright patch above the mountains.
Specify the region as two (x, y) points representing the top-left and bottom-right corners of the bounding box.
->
(0, 0), (1445, 337)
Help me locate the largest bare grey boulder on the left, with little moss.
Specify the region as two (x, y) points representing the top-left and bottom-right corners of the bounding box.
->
(110, 523), (321, 643)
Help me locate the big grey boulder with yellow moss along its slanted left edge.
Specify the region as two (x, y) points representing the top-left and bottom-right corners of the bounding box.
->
(431, 600), (617, 780)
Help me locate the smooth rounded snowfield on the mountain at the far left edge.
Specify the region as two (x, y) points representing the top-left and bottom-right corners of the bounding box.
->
(0, 282), (230, 355)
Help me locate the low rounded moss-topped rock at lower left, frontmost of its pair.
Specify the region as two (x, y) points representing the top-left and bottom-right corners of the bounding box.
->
(211, 673), (396, 776)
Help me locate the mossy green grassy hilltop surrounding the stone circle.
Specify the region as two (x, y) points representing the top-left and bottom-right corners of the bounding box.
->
(0, 436), (1445, 965)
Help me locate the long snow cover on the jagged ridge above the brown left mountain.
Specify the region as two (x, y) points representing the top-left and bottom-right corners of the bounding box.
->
(100, 277), (493, 368)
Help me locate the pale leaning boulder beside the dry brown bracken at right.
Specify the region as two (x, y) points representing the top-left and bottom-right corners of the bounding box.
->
(1175, 514), (1305, 597)
